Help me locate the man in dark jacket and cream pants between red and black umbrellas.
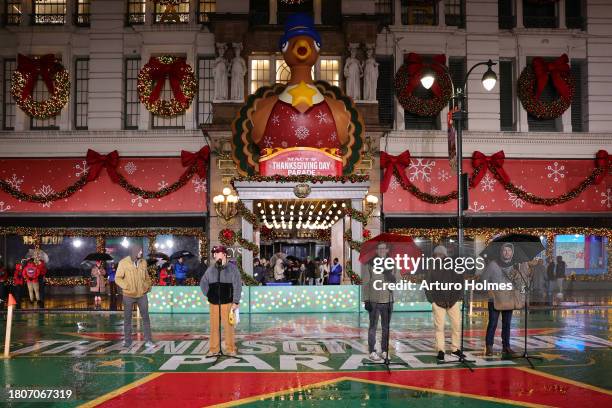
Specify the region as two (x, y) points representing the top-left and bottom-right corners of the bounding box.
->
(425, 245), (463, 363)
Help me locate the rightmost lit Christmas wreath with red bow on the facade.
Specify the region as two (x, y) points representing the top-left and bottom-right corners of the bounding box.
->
(518, 54), (575, 119)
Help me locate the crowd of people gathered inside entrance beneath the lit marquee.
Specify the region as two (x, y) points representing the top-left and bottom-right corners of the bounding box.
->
(253, 253), (342, 286)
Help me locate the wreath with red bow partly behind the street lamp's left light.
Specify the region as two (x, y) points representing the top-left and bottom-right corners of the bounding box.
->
(395, 52), (453, 116)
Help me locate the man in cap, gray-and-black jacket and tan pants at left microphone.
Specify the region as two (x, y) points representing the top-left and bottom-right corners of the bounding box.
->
(200, 245), (242, 357)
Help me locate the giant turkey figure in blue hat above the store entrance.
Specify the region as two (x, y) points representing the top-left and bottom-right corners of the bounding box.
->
(232, 14), (364, 176)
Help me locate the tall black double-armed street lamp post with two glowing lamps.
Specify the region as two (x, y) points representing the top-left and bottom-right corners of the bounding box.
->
(421, 60), (497, 256)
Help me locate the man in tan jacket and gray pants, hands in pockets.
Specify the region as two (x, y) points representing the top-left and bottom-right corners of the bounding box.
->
(115, 245), (155, 348)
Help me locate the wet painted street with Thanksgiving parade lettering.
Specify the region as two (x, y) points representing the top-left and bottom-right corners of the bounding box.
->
(0, 307), (612, 408)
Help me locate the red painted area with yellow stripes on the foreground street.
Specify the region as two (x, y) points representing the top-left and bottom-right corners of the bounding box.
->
(92, 367), (612, 408)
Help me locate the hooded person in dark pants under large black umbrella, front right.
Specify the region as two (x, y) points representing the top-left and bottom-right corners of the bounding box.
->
(482, 243), (528, 358)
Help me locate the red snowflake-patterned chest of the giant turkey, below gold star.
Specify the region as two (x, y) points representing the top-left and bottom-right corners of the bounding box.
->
(259, 100), (340, 151)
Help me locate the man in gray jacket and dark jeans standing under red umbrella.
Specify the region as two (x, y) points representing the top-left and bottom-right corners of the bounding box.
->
(361, 242), (397, 361)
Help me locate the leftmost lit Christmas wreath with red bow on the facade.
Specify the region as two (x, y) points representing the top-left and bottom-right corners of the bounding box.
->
(11, 54), (70, 119)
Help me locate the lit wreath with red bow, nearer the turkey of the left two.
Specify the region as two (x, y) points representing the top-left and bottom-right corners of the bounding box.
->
(138, 56), (197, 117)
